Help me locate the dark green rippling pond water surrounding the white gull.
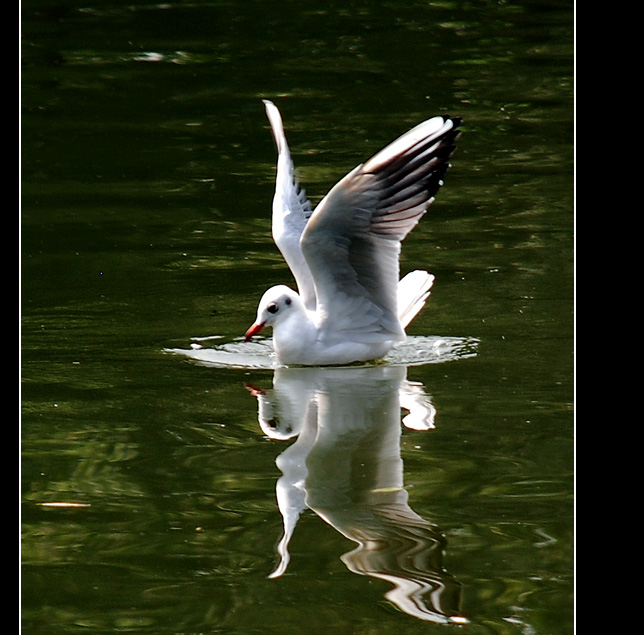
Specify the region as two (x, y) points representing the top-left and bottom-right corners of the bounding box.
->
(20, 0), (574, 635)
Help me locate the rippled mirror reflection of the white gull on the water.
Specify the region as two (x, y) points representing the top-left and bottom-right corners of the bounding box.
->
(251, 366), (465, 623)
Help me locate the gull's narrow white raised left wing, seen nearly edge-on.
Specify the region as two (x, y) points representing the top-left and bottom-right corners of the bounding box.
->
(264, 100), (315, 310)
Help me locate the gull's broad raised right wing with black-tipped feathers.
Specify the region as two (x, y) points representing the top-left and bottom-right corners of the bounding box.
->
(301, 117), (460, 341)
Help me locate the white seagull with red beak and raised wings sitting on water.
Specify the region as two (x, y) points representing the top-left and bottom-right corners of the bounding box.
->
(244, 100), (461, 366)
